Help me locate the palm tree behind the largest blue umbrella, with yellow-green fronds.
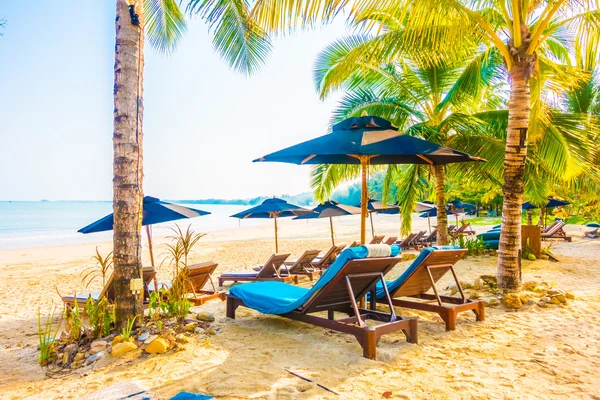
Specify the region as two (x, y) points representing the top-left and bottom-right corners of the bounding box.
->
(313, 29), (502, 244)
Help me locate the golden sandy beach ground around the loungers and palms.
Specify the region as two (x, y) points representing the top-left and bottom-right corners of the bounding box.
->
(0, 218), (600, 399)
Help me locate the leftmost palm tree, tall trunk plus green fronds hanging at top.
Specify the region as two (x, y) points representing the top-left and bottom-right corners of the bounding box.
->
(113, 0), (278, 324)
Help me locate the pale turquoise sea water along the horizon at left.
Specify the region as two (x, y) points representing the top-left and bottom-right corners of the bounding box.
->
(0, 201), (258, 249)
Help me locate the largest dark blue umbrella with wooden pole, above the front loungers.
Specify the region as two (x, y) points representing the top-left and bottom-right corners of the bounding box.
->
(254, 116), (484, 243)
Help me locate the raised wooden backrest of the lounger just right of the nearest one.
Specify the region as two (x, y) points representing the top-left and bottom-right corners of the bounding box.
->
(390, 249), (467, 297)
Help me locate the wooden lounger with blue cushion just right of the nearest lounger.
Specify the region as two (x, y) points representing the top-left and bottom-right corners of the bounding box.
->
(370, 246), (485, 331)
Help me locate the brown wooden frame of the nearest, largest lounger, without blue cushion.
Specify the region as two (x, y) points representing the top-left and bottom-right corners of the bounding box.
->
(227, 257), (418, 359)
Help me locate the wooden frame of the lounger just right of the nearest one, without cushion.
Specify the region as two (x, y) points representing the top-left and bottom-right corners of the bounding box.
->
(378, 249), (485, 331)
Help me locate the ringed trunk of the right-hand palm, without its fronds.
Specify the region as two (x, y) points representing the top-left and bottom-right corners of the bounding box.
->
(498, 60), (530, 290)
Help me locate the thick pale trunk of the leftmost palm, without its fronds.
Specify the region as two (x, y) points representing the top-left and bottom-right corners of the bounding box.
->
(113, 0), (144, 326)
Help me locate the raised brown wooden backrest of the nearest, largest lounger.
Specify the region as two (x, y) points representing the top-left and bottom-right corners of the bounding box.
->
(301, 257), (400, 314)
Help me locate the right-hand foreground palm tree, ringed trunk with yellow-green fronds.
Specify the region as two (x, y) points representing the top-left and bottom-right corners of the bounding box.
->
(254, 0), (600, 289)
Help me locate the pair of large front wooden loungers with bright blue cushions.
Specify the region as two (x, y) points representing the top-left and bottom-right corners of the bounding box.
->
(227, 246), (485, 359)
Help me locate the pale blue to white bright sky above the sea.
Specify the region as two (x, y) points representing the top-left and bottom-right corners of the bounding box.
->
(0, 0), (345, 200)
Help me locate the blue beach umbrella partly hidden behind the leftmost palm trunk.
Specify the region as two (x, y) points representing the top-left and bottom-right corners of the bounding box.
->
(77, 196), (210, 266)
